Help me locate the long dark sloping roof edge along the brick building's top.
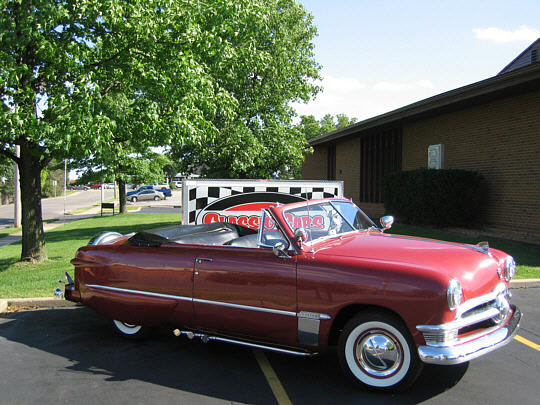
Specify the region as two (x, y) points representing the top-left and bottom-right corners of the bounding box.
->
(309, 63), (540, 146)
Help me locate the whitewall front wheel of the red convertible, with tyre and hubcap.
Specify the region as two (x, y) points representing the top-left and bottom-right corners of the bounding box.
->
(338, 311), (423, 391)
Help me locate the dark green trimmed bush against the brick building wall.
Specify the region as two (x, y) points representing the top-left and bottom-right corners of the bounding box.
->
(383, 169), (487, 227)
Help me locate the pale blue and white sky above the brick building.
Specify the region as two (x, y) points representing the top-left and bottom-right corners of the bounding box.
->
(294, 0), (540, 120)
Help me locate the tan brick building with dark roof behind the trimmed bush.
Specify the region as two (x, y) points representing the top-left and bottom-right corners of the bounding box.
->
(302, 39), (540, 244)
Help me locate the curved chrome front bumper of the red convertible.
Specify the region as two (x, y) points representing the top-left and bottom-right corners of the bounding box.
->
(418, 305), (521, 365)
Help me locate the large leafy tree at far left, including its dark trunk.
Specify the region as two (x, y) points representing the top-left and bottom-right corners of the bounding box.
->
(0, 0), (239, 261)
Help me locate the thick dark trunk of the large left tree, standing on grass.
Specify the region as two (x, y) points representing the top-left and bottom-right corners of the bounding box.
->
(19, 145), (47, 262)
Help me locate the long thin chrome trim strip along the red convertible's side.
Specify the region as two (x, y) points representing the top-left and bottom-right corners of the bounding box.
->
(85, 284), (331, 320)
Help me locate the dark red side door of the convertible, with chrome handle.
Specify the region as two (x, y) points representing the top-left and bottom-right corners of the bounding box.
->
(193, 241), (298, 345)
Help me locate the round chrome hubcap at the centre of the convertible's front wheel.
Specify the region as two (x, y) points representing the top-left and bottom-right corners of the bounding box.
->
(355, 330), (403, 378)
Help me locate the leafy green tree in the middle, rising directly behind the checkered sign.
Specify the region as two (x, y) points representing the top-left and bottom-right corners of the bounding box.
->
(171, 0), (320, 178)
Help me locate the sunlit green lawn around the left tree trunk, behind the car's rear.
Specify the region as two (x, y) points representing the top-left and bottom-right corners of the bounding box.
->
(0, 214), (180, 298)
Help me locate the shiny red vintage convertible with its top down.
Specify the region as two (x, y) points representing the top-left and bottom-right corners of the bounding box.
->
(57, 199), (521, 390)
